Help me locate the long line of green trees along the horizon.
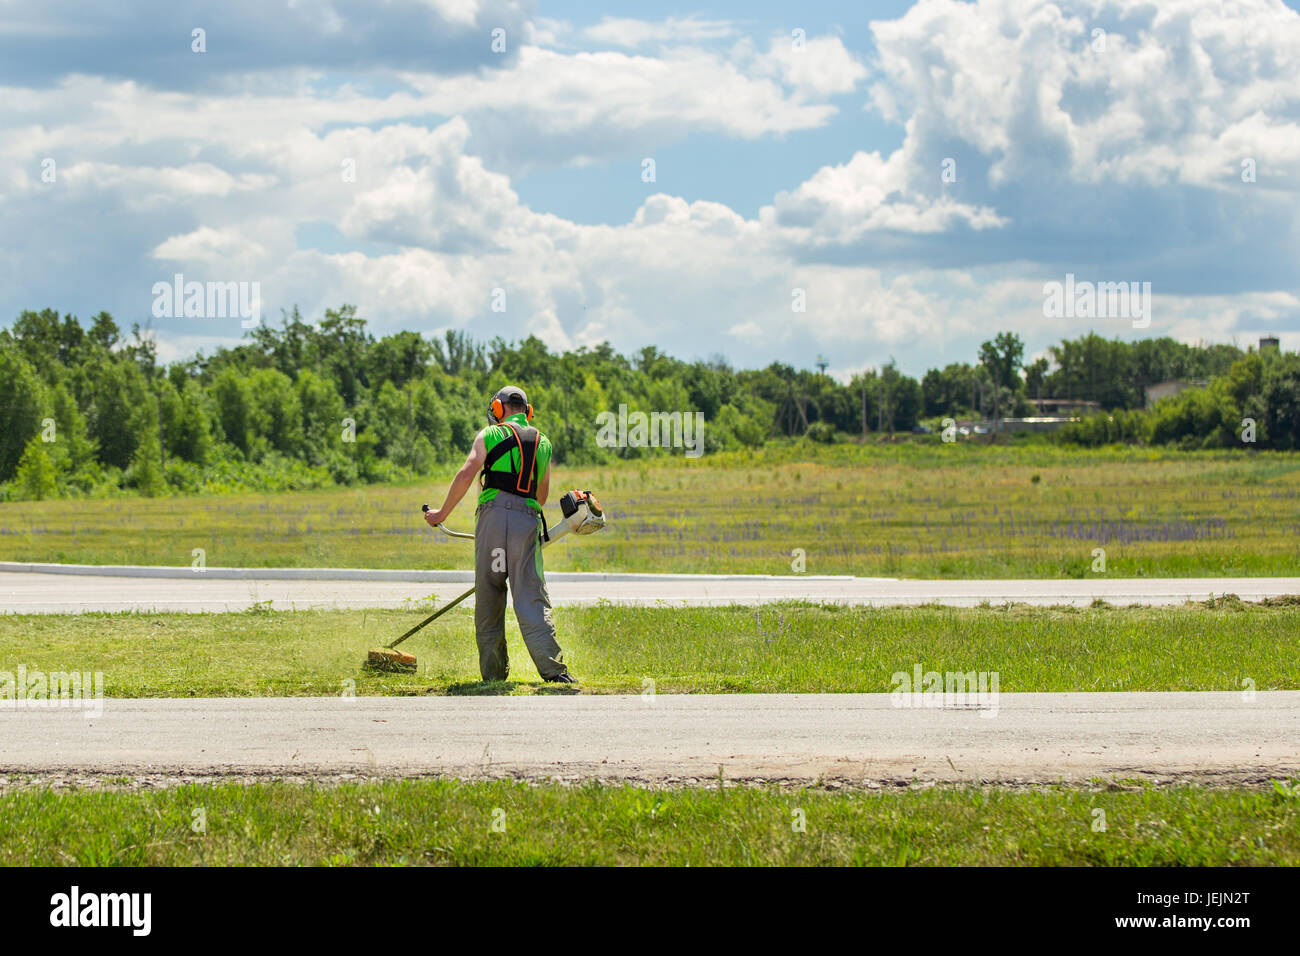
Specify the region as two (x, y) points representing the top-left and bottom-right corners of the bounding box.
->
(0, 306), (1300, 498)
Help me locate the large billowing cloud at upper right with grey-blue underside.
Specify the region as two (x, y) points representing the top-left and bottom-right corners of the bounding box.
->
(763, 0), (1300, 293)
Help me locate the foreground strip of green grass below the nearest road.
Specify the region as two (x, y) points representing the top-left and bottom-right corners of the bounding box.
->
(0, 780), (1300, 866)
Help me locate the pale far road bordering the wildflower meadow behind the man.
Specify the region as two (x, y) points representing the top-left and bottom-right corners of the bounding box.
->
(0, 564), (1300, 614)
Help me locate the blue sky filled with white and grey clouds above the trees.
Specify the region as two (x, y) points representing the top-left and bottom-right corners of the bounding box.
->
(0, 0), (1300, 376)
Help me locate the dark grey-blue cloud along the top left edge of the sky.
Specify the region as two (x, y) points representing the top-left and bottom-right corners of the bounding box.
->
(0, 0), (528, 88)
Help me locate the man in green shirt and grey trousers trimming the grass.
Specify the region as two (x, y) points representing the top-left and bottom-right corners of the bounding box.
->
(424, 385), (573, 684)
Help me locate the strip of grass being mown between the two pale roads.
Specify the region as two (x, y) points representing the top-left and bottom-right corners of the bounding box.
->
(0, 600), (1300, 697)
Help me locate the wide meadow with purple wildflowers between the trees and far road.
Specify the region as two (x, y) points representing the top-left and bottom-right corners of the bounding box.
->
(0, 442), (1300, 578)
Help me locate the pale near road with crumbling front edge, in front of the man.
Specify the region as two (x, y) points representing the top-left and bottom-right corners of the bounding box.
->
(0, 691), (1300, 786)
